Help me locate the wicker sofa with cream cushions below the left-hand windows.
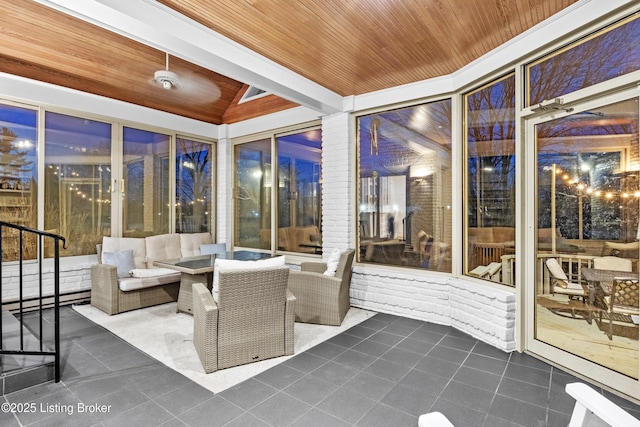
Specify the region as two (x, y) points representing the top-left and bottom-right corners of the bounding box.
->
(91, 233), (211, 314)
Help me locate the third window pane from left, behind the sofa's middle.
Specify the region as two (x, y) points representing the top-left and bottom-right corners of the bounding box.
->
(122, 127), (171, 237)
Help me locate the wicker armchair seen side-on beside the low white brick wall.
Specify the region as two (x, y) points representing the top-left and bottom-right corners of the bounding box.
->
(289, 249), (355, 326)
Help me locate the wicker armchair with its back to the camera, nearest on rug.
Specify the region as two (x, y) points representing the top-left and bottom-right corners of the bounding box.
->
(193, 267), (296, 373)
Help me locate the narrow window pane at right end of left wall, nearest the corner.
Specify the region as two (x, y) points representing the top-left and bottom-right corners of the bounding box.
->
(176, 138), (213, 233)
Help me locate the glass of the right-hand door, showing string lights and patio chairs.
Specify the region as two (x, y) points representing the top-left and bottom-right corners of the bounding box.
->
(535, 98), (640, 378)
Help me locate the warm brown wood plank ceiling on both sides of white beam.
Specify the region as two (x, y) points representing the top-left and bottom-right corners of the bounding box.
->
(0, 0), (577, 124)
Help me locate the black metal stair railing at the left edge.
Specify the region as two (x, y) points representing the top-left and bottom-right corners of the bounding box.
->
(0, 221), (66, 382)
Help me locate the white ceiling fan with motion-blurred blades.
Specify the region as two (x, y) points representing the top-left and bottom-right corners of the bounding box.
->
(149, 52), (220, 102)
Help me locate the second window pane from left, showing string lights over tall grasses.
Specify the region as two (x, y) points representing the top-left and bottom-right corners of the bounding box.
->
(44, 112), (111, 256)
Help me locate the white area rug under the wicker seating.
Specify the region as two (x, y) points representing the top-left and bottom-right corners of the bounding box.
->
(74, 303), (376, 393)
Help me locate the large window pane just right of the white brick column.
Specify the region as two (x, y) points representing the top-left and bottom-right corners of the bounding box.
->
(357, 100), (452, 272)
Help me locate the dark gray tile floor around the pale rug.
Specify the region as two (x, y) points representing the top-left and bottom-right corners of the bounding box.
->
(0, 307), (640, 427)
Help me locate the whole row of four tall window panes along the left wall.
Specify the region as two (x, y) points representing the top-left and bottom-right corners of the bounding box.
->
(0, 102), (215, 261)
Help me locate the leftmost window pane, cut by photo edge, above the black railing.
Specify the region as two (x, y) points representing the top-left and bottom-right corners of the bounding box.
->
(0, 105), (38, 261)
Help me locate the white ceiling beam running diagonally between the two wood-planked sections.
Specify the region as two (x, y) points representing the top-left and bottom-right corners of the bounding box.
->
(36, 0), (343, 114)
